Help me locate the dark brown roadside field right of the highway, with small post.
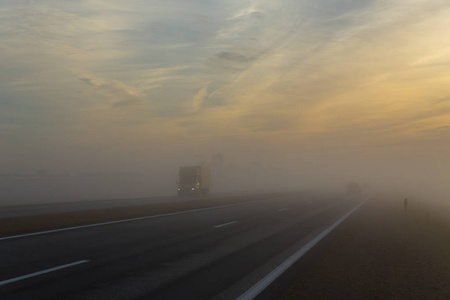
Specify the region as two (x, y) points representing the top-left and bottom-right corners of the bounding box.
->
(281, 198), (450, 300)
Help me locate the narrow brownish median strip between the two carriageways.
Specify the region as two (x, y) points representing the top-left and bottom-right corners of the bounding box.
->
(0, 193), (292, 240)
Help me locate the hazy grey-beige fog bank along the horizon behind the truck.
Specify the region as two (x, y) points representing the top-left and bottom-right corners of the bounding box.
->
(0, 145), (450, 205)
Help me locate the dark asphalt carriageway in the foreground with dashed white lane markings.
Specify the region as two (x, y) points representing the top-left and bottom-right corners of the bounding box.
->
(0, 194), (364, 299)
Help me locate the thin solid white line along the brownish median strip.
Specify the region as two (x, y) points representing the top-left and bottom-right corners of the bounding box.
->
(0, 196), (290, 241)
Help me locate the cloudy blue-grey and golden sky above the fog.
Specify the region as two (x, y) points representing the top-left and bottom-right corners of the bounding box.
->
(0, 0), (450, 197)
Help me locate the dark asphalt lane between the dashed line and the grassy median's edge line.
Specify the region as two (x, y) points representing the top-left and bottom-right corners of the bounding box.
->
(0, 196), (302, 279)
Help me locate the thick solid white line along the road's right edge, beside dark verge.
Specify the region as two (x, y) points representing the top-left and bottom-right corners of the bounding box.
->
(236, 199), (368, 300)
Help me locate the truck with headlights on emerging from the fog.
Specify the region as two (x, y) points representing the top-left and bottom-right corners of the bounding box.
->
(177, 165), (210, 196)
